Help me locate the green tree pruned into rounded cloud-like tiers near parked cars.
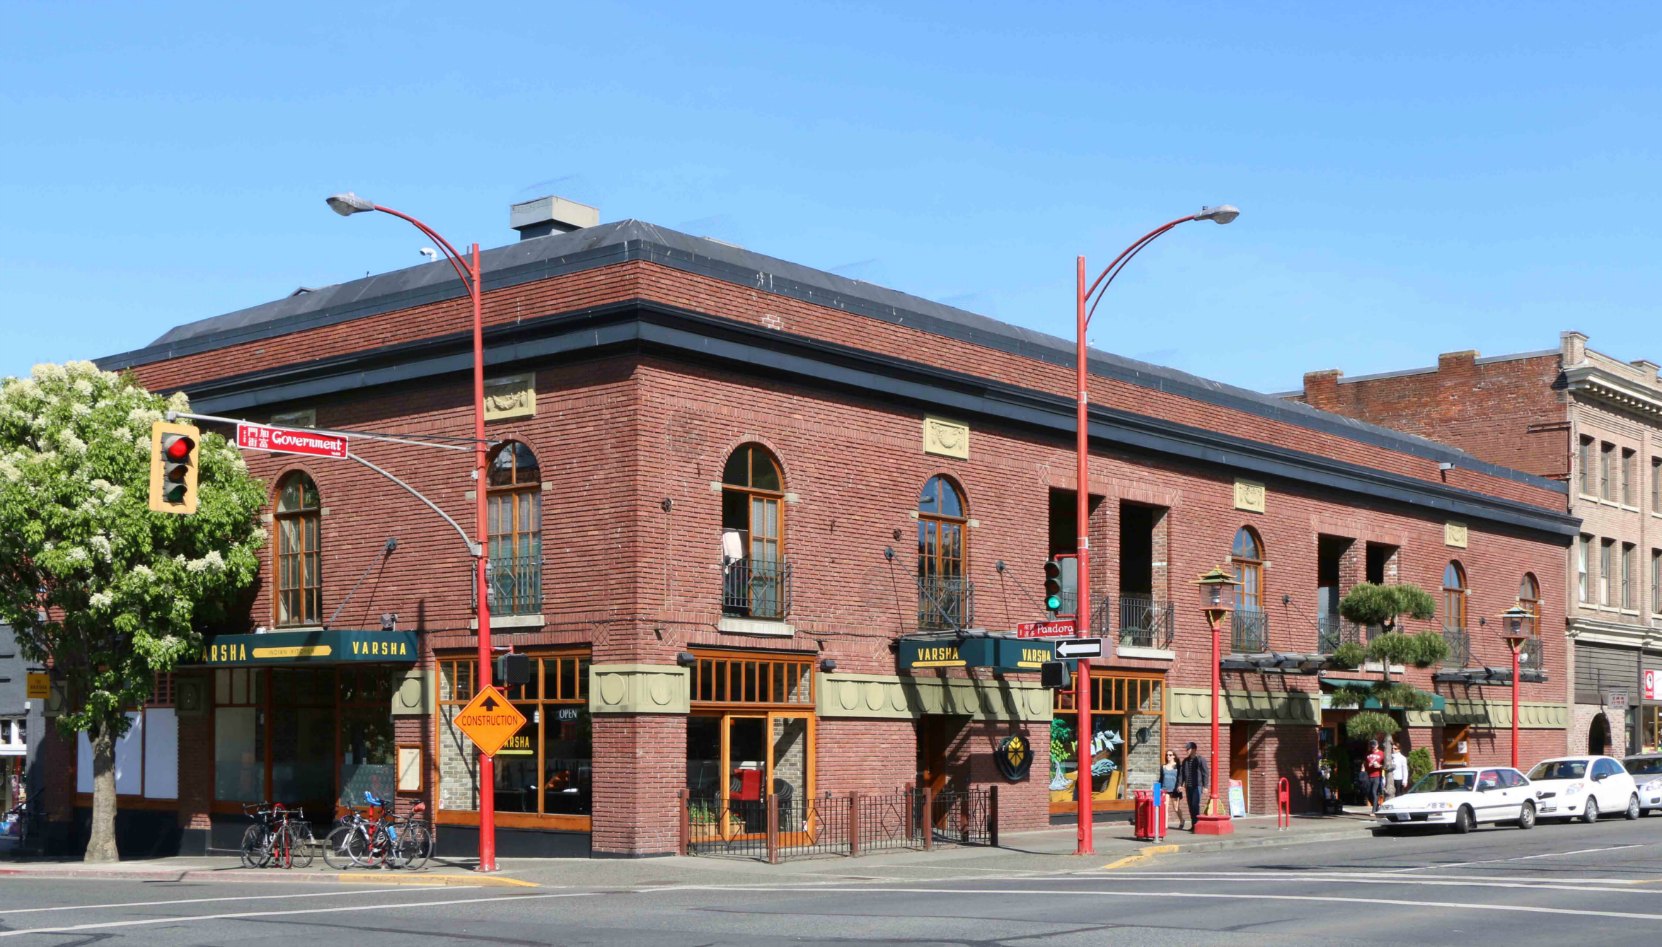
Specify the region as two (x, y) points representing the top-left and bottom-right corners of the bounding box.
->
(1331, 581), (1448, 794)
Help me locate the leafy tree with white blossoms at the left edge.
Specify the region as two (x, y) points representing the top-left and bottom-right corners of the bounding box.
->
(0, 362), (264, 861)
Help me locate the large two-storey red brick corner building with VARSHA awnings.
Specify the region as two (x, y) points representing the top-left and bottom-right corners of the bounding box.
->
(51, 195), (1576, 856)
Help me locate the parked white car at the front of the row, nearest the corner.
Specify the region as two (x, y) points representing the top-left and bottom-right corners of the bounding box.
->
(1374, 766), (1536, 832)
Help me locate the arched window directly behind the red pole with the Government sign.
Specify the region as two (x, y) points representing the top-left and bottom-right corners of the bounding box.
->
(485, 440), (542, 615)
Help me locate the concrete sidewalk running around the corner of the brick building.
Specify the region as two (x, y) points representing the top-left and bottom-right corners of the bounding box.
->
(0, 814), (1373, 889)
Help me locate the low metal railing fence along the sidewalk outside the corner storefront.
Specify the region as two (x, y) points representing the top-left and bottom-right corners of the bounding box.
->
(678, 786), (999, 864)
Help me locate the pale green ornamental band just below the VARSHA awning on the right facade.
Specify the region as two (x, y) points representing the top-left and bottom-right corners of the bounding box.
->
(814, 673), (1052, 721)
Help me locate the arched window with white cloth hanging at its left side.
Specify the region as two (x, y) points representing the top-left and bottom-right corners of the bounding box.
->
(721, 444), (789, 621)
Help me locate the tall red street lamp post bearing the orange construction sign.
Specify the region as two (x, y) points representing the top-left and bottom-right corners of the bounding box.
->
(327, 191), (497, 871)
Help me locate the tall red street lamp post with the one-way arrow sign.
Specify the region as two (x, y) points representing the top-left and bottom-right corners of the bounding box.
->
(1074, 204), (1240, 856)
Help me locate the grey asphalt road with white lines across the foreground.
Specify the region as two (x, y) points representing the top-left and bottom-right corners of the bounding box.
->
(0, 817), (1662, 947)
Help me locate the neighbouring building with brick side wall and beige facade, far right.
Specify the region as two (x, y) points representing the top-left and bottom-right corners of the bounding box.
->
(1296, 332), (1662, 754)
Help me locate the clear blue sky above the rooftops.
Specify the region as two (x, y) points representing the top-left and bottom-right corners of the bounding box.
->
(0, 0), (1662, 390)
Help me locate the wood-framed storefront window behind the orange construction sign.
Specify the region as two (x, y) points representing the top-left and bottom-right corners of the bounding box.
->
(439, 651), (593, 817)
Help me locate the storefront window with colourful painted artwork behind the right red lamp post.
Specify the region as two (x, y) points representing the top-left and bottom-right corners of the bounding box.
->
(1050, 675), (1165, 811)
